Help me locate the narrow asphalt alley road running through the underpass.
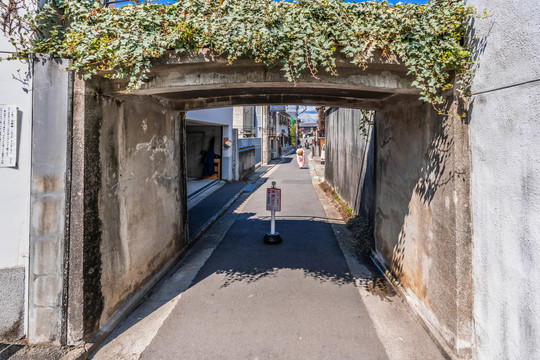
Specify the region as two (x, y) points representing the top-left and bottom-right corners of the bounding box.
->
(94, 156), (442, 359)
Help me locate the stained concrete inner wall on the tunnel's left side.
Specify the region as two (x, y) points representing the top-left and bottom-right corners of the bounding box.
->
(67, 77), (188, 344)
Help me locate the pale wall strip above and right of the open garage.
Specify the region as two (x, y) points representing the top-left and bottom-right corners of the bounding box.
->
(186, 107), (234, 181)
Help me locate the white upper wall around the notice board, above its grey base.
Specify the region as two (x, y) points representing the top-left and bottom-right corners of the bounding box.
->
(0, 33), (32, 268)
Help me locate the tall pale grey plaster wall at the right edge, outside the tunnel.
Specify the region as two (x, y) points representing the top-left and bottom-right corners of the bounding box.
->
(469, 0), (540, 360)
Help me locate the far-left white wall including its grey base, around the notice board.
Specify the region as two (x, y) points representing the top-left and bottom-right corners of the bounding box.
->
(0, 34), (32, 340)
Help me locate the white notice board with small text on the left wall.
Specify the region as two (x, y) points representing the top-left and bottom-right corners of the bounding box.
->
(0, 105), (18, 167)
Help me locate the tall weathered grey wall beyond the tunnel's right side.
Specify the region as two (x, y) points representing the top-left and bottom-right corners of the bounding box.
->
(324, 108), (375, 221)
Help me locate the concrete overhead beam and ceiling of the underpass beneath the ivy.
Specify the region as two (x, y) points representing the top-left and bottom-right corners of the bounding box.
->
(114, 49), (419, 110)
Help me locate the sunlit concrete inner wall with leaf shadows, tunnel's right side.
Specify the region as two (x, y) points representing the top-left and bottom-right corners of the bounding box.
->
(375, 95), (472, 357)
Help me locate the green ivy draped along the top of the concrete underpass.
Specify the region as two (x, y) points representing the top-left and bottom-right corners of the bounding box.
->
(8, 0), (477, 105)
